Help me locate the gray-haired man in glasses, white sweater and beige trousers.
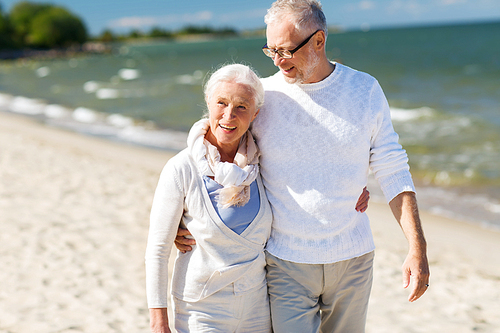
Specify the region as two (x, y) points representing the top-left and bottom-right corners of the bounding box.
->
(178, 0), (429, 333)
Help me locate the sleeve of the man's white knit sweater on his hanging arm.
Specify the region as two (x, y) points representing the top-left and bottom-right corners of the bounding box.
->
(370, 82), (415, 202)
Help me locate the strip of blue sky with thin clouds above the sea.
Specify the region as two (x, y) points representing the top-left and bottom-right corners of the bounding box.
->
(0, 0), (500, 36)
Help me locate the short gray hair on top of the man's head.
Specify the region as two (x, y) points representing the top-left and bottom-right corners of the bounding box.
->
(264, 0), (328, 35)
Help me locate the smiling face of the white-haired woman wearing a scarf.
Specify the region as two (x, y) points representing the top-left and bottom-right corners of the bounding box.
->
(205, 82), (259, 154)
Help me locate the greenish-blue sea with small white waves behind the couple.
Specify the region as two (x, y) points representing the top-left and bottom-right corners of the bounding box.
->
(0, 21), (500, 230)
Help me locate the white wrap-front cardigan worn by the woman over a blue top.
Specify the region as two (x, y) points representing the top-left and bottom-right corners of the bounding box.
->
(146, 149), (272, 308)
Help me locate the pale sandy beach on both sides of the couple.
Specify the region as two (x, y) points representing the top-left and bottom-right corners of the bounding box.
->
(0, 112), (500, 333)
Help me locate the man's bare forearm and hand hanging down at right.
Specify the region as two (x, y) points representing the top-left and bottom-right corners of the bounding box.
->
(389, 192), (430, 302)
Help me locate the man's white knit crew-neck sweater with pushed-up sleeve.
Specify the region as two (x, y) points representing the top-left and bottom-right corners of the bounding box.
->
(252, 64), (415, 264)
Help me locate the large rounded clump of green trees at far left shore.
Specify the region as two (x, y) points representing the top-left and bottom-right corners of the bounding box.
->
(0, 1), (88, 49)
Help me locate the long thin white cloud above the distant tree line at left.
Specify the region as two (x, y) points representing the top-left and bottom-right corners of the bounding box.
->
(108, 11), (213, 29)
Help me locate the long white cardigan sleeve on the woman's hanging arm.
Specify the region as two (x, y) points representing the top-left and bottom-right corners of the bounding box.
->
(146, 159), (184, 308)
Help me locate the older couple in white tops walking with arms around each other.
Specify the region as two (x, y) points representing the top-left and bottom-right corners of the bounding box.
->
(146, 0), (429, 333)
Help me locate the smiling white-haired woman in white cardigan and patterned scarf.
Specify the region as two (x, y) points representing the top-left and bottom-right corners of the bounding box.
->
(146, 64), (272, 332)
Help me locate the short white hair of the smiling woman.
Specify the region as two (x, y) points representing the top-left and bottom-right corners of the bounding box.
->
(203, 64), (264, 109)
